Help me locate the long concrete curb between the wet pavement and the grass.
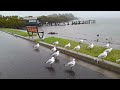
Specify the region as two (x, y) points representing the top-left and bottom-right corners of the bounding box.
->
(2, 31), (120, 74)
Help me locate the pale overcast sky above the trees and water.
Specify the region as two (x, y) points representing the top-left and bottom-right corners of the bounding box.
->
(0, 11), (120, 18)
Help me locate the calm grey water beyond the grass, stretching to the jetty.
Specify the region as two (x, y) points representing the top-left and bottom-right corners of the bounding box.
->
(39, 18), (120, 49)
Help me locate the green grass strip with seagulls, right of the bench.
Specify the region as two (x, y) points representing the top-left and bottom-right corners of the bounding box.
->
(34, 37), (120, 64)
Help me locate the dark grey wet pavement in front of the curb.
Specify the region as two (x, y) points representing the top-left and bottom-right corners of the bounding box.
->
(0, 32), (118, 79)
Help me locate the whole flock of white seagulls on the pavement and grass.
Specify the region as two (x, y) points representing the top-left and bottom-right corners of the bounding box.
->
(34, 40), (120, 68)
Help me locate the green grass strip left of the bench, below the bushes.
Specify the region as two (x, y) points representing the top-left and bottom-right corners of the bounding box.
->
(0, 28), (36, 37)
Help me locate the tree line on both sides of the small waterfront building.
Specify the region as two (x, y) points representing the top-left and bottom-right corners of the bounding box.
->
(0, 13), (77, 29)
